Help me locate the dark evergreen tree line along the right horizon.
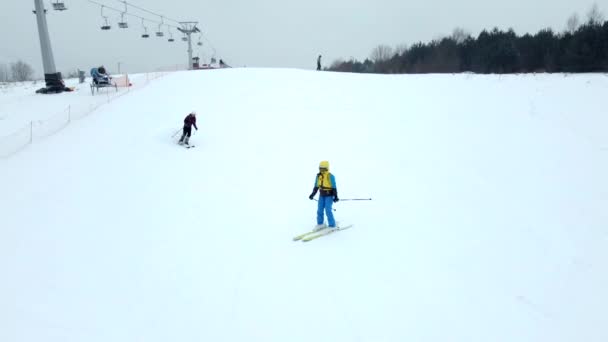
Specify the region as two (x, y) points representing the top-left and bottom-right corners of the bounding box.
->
(326, 4), (608, 74)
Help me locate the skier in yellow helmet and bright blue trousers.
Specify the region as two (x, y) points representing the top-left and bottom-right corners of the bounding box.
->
(308, 160), (339, 230)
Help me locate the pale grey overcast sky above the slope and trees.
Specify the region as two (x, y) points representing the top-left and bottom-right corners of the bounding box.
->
(0, 0), (608, 76)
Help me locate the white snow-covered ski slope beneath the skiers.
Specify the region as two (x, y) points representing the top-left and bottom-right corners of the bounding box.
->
(0, 69), (608, 342)
